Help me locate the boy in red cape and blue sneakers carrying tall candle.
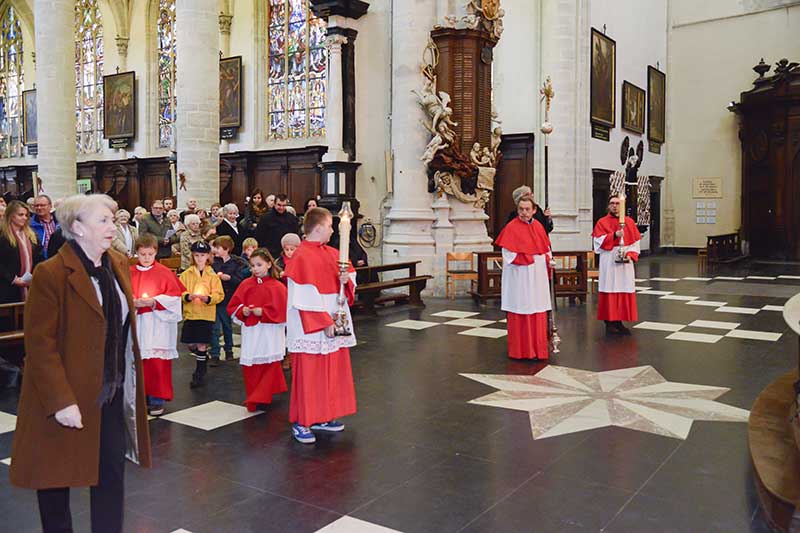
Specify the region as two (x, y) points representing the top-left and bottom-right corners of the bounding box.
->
(286, 207), (356, 444)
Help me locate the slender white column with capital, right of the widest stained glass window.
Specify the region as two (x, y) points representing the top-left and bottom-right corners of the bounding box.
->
(322, 34), (350, 161)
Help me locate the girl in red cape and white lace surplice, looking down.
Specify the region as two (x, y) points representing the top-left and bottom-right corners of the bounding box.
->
(227, 248), (288, 412)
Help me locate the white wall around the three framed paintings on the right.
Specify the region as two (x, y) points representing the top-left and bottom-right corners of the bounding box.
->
(587, 0), (669, 177)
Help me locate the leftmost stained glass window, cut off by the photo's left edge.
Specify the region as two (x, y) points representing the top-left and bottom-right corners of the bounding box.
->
(0, 6), (25, 157)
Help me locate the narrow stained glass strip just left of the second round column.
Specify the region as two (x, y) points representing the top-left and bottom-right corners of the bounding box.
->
(158, 0), (177, 148)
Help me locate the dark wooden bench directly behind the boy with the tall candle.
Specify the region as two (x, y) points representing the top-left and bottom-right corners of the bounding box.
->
(353, 261), (433, 314)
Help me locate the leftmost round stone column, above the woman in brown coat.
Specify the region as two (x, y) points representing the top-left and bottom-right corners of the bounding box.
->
(34, 0), (77, 199)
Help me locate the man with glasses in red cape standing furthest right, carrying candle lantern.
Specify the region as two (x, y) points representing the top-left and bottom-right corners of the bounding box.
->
(592, 196), (642, 335)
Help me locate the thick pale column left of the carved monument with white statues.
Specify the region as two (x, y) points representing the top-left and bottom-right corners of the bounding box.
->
(383, 1), (437, 273)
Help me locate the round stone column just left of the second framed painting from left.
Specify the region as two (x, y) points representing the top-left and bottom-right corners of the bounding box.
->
(175, 0), (219, 208)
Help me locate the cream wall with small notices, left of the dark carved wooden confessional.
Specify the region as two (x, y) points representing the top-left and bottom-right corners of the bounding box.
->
(666, 0), (800, 247)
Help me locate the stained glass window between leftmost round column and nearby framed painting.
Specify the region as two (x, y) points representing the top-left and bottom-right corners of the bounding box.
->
(75, 0), (103, 154)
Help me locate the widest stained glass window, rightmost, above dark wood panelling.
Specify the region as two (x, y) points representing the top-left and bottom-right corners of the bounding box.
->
(265, 0), (328, 139)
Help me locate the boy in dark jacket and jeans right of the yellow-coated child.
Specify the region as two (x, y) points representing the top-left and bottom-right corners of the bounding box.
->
(209, 235), (250, 366)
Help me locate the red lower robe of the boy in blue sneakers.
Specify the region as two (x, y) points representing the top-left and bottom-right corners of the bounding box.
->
(289, 348), (356, 426)
